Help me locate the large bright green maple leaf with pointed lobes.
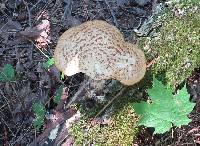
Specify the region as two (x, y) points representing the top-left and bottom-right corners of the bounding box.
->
(133, 78), (195, 134)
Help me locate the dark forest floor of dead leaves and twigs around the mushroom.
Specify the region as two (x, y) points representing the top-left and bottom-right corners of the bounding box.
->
(0, 0), (200, 146)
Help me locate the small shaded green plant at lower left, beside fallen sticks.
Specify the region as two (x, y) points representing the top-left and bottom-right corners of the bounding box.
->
(33, 103), (45, 130)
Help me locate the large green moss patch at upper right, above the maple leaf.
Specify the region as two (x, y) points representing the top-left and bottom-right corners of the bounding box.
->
(139, 1), (200, 88)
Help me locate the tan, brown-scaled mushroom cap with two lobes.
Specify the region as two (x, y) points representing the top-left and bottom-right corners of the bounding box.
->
(54, 20), (146, 85)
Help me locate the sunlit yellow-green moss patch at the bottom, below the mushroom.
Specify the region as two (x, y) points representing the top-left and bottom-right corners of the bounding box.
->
(70, 106), (137, 146)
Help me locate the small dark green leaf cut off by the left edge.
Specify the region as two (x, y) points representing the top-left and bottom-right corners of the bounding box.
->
(0, 64), (15, 82)
